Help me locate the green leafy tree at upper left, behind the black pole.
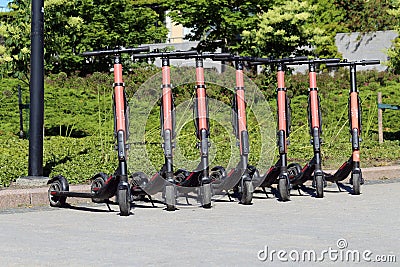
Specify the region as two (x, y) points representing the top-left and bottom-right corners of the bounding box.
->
(0, 0), (167, 76)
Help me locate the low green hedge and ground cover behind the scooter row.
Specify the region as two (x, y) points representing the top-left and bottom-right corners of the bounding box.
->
(0, 67), (400, 186)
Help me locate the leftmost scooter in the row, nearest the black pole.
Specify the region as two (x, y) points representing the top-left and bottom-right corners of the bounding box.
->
(48, 47), (149, 216)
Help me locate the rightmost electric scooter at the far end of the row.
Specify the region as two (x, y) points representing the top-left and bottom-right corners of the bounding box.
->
(325, 60), (380, 195)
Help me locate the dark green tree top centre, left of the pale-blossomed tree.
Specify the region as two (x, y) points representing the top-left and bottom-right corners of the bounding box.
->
(164, 0), (274, 51)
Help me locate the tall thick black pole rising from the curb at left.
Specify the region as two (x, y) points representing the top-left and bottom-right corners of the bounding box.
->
(28, 0), (44, 176)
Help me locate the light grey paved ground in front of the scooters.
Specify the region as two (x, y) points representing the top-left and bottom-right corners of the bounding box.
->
(0, 179), (400, 266)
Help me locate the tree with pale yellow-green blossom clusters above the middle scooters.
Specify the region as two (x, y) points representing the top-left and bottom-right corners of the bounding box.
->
(243, 0), (326, 57)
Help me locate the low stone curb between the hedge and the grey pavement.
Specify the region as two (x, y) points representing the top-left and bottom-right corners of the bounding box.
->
(0, 165), (400, 210)
